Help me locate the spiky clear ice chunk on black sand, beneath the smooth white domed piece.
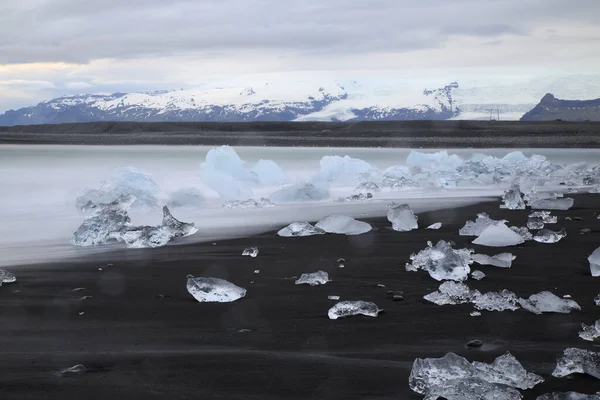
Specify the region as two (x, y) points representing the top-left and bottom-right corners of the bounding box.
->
(406, 240), (473, 281)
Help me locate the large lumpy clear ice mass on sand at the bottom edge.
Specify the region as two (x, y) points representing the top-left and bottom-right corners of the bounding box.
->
(408, 353), (544, 400)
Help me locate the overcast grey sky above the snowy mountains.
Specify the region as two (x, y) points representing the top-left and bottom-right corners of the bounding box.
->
(0, 0), (600, 112)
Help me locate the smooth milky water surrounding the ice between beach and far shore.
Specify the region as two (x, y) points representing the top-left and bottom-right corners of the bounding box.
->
(0, 145), (600, 266)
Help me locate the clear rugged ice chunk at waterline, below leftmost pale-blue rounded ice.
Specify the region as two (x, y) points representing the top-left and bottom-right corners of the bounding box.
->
(71, 195), (135, 246)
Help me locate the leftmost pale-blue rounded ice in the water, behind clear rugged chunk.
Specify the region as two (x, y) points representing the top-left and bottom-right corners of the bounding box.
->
(75, 167), (160, 212)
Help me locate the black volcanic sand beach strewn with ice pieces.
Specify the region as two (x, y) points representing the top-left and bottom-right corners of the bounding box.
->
(0, 195), (600, 400)
